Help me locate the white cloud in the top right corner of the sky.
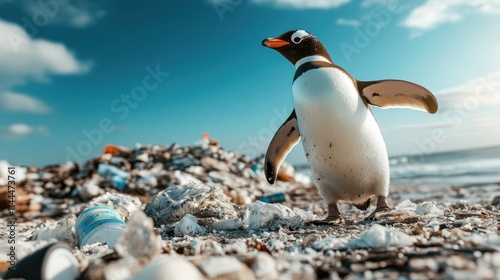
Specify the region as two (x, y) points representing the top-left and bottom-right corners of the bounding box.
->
(401, 0), (500, 31)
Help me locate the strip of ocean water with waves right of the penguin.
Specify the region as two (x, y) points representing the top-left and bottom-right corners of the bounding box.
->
(389, 146), (500, 186)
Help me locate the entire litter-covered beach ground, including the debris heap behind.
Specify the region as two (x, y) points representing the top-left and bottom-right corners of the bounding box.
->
(0, 142), (500, 280)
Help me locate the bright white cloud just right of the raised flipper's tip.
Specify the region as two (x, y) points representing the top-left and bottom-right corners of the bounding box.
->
(436, 72), (500, 112)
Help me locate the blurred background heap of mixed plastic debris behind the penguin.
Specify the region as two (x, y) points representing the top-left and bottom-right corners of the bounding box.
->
(0, 144), (311, 219)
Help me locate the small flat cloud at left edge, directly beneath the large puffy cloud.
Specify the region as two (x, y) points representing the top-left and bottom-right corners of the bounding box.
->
(0, 91), (50, 114)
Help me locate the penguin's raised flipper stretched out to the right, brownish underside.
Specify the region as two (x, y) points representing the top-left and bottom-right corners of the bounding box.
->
(357, 80), (438, 114)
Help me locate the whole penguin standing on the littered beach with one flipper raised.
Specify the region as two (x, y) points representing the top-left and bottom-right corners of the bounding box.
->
(262, 30), (438, 224)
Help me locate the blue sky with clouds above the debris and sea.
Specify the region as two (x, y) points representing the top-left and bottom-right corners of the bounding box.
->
(0, 0), (500, 165)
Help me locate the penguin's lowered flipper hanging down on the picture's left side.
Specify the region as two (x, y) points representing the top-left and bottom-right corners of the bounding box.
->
(264, 109), (300, 185)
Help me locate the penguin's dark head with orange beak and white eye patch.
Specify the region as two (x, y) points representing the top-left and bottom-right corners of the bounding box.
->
(262, 30), (332, 65)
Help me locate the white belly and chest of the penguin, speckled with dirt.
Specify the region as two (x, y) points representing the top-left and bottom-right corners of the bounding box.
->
(292, 67), (389, 203)
